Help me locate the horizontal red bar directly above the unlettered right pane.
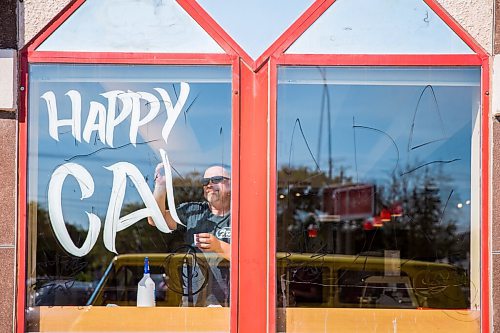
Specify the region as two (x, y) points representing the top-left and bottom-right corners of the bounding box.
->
(277, 54), (482, 66)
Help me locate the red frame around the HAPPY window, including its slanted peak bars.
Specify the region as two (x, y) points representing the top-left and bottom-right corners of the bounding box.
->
(16, 0), (245, 332)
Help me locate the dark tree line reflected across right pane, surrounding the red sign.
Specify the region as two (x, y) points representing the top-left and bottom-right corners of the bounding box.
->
(277, 167), (469, 266)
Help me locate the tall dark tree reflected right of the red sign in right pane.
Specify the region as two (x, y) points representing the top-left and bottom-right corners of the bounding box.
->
(378, 168), (469, 262)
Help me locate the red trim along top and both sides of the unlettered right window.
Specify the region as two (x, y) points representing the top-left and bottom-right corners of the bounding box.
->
(268, 55), (492, 333)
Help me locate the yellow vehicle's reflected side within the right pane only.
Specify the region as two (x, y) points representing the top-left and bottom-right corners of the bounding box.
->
(277, 254), (470, 309)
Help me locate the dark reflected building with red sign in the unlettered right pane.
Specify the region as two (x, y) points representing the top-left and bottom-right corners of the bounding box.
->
(278, 184), (378, 254)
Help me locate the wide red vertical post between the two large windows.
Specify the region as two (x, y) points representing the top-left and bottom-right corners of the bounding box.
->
(238, 63), (274, 333)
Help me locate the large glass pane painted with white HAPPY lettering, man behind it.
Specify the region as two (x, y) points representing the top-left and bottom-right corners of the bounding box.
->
(26, 64), (232, 332)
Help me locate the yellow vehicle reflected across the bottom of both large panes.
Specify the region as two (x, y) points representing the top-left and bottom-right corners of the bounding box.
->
(88, 253), (469, 309)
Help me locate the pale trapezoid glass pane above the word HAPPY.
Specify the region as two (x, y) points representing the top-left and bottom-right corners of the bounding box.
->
(37, 0), (225, 54)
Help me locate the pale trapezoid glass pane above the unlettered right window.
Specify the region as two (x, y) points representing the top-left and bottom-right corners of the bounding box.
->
(286, 0), (474, 54)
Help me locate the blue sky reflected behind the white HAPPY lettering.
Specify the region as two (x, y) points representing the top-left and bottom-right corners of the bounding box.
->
(29, 65), (231, 225)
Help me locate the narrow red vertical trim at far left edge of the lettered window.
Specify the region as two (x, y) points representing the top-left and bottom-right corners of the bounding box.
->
(16, 52), (28, 333)
